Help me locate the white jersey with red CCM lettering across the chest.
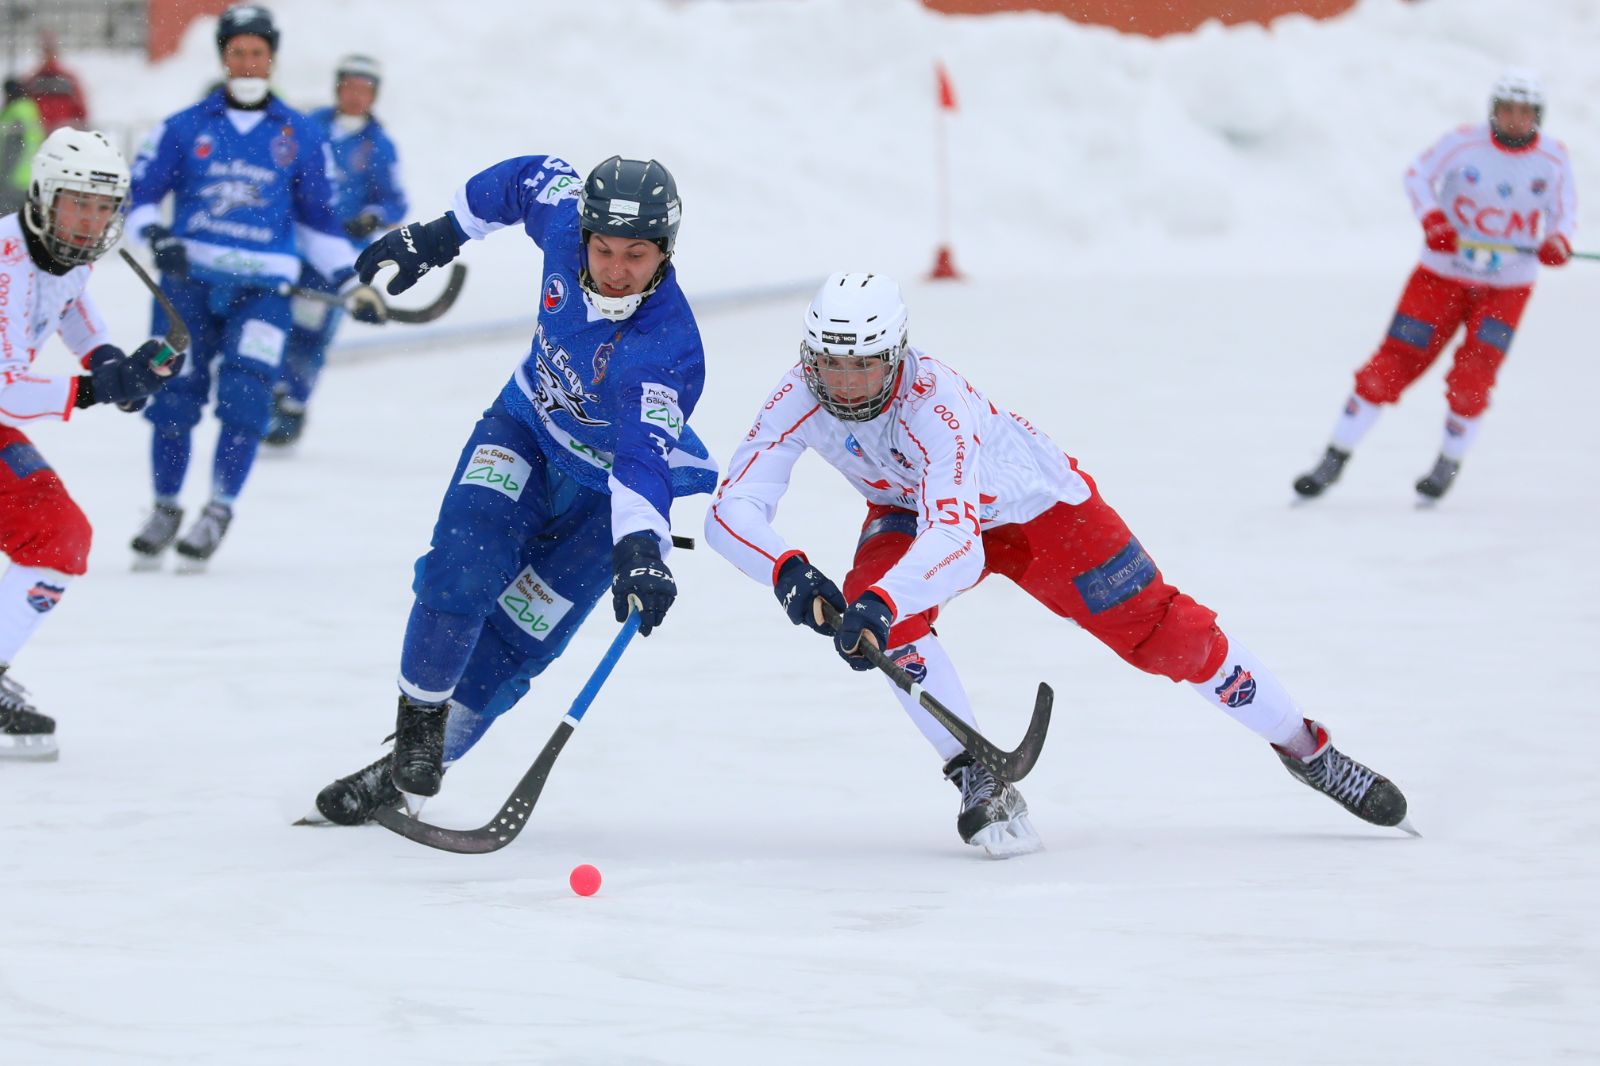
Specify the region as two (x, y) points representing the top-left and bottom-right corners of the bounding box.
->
(1405, 122), (1578, 288)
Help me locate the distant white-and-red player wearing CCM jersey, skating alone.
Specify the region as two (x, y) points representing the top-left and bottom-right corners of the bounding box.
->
(1294, 70), (1578, 503)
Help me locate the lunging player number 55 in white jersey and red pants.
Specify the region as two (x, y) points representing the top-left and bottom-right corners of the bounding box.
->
(706, 274), (1406, 855)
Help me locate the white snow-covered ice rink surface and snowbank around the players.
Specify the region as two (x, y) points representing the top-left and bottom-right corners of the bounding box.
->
(0, 0), (1600, 1066)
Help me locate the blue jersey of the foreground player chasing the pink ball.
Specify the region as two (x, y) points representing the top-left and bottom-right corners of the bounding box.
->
(451, 155), (717, 541)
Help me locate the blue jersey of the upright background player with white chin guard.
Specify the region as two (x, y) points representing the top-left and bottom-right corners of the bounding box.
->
(128, 90), (355, 287)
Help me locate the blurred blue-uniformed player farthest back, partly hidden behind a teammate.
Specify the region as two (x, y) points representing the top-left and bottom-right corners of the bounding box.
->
(264, 54), (406, 445)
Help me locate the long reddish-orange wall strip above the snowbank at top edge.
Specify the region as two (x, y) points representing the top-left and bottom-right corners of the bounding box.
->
(922, 0), (1355, 37)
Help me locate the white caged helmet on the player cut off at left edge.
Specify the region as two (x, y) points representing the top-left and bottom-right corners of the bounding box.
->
(22, 126), (128, 266)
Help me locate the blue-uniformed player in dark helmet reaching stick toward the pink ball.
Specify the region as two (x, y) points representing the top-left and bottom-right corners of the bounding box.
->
(308, 155), (717, 824)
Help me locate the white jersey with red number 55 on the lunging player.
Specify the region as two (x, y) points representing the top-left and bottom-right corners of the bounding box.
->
(706, 349), (1090, 618)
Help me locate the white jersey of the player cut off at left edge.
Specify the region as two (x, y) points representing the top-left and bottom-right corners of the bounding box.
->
(0, 214), (110, 426)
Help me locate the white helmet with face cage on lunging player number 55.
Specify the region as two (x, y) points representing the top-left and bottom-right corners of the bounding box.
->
(800, 274), (906, 423)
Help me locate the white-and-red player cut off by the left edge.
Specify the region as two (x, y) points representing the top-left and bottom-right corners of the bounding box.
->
(0, 128), (181, 759)
